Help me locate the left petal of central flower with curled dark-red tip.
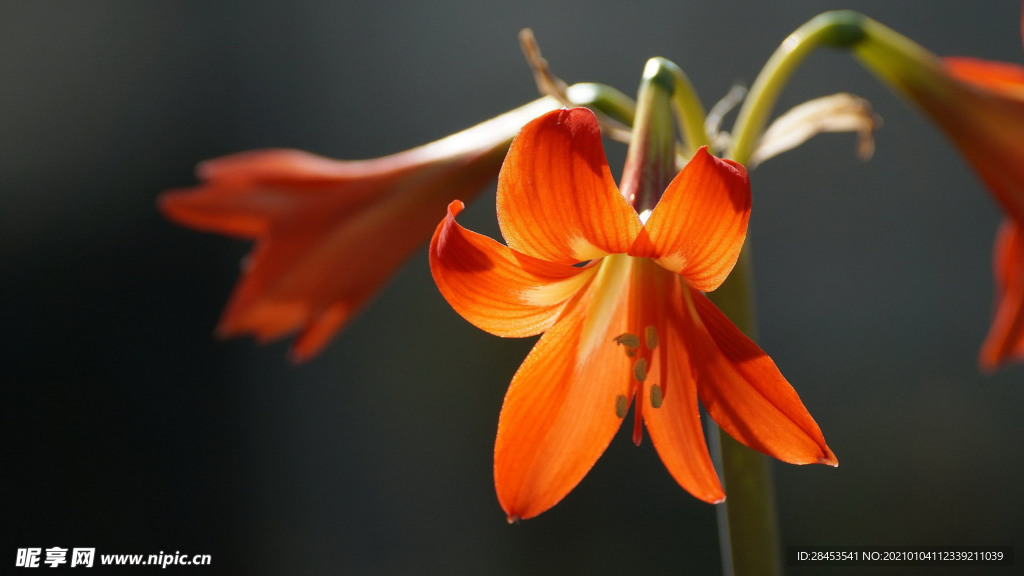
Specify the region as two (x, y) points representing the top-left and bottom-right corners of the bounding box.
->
(430, 200), (594, 336)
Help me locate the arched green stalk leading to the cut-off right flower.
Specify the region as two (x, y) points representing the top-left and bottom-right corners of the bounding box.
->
(728, 10), (867, 164)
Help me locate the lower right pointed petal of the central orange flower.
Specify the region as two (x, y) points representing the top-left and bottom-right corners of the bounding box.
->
(672, 289), (838, 465)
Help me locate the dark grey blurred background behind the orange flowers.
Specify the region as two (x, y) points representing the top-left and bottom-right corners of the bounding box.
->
(6, 0), (1024, 575)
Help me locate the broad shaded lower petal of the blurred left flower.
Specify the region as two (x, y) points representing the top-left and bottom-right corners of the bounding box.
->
(218, 167), (476, 359)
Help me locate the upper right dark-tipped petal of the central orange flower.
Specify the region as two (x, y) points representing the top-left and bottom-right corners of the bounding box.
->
(630, 147), (751, 292)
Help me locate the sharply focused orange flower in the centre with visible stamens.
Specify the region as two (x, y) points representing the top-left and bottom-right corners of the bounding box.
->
(430, 109), (836, 521)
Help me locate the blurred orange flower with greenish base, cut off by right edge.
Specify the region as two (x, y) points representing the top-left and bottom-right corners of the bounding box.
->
(854, 15), (1024, 370)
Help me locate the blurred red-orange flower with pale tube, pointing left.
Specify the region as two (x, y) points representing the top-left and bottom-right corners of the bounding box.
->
(159, 98), (557, 362)
